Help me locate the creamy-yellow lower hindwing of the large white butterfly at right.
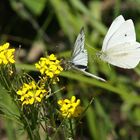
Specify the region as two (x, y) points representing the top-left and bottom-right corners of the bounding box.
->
(100, 42), (140, 69)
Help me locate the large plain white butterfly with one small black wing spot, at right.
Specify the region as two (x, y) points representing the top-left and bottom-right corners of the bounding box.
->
(100, 15), (140, 69)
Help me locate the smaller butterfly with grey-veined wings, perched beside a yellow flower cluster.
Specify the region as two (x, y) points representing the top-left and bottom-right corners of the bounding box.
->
(70, 28), (105, 81)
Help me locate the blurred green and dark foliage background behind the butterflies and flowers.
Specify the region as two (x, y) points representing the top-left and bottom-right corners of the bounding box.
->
(0, 0), (140, 140)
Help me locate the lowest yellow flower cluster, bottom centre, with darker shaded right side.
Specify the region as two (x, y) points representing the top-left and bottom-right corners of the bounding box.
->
(58, 96), (83, 118)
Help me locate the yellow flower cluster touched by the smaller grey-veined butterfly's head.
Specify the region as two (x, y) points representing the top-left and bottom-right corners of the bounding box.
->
(35, 54), (63, 78)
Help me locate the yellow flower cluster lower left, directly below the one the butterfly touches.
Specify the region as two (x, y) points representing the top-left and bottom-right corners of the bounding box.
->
(17, 81), (47, 105)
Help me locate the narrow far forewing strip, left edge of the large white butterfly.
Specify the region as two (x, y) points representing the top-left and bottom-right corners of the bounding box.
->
(102, 15), (125, 51)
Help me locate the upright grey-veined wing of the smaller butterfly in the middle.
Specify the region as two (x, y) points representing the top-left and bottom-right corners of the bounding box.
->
(71, 28), (88, 69)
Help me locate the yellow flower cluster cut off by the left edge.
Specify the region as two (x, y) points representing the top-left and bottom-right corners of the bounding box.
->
(0, 43), (15, 65)
